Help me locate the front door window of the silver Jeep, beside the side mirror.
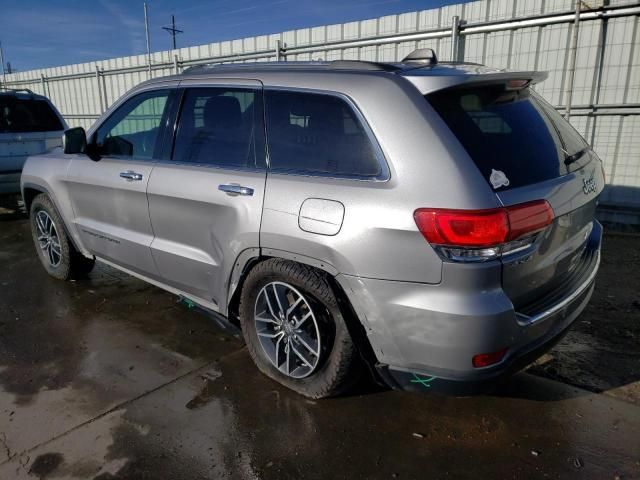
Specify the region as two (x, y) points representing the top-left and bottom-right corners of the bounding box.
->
(95, 90), (170, 159)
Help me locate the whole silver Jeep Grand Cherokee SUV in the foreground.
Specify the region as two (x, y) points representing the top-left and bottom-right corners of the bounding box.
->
(22, 52), (604, 398)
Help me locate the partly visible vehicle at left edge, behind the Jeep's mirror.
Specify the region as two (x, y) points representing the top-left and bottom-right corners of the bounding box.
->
(0, 87), (67, 195)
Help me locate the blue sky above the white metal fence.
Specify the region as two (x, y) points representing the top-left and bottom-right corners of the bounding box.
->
(0, 0), (468, 71)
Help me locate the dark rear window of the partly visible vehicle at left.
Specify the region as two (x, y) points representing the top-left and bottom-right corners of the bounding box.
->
(0, 96), (64, 133)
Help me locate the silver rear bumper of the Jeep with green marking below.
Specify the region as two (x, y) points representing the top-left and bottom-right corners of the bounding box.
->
(338, 222), (602, 395)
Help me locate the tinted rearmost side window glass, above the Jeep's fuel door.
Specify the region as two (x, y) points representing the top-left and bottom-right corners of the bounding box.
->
(265, 91), (382, 177)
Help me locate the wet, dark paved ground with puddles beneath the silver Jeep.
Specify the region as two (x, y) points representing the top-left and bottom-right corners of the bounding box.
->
(0, 207), (640, 480)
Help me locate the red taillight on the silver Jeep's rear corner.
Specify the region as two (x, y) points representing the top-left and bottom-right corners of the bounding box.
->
(414, 200), (554, 261)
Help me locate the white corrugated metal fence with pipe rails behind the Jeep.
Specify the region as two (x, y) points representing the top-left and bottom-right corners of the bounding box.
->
(1, 0), (640, 223)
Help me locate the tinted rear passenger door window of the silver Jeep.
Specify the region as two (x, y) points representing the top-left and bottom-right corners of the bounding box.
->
(172, 87), (264, 168)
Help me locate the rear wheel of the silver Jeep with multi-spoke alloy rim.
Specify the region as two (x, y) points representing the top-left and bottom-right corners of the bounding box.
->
(240, 259), (361, 398)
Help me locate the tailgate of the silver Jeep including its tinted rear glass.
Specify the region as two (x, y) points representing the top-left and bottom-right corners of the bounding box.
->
(425, 79), (604, 311)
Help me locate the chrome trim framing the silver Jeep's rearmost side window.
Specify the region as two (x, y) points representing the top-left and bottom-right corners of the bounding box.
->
(264, 85), (391, 182)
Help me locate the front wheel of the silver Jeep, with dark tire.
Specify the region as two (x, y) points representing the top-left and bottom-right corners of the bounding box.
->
(30, 193), (95, 280)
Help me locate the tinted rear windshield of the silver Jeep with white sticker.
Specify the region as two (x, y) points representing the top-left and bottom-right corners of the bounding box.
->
(426, 86), (588, 191)
